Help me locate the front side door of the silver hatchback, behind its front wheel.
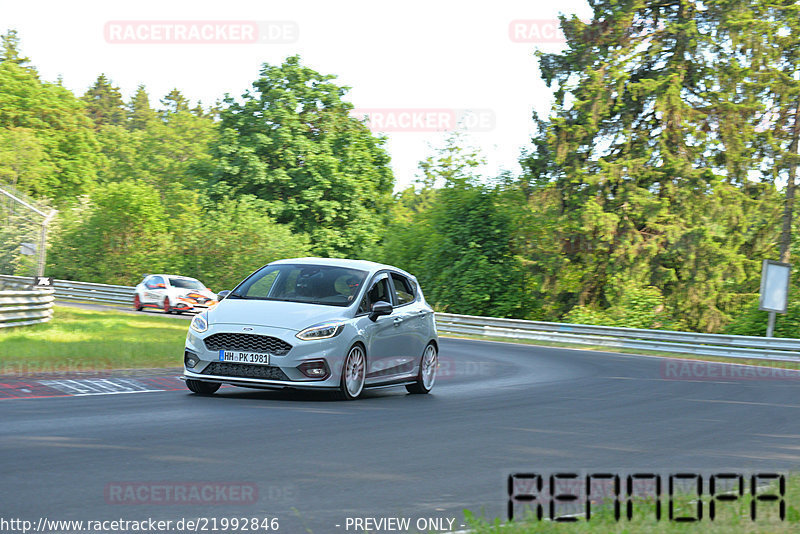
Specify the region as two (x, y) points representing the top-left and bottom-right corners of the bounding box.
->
(358, 272), (403, 383)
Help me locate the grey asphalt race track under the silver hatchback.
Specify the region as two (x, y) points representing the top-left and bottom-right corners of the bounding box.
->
(0, 339), (800, 533)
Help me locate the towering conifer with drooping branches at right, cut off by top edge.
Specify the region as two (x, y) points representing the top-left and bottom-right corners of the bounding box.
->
(523, 0), (775, 330)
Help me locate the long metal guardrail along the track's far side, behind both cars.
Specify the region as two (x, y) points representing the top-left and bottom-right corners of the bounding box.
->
(0, 275), (800, 362)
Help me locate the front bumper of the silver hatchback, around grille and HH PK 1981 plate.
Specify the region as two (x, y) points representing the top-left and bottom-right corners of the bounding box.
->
(183, 324), (347, 389)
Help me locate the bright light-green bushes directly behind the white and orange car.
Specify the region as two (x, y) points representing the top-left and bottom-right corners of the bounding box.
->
(48, 181), (310, 291)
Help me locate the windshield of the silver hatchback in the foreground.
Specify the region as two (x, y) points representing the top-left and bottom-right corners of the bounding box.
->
(228, 264), (367, 306)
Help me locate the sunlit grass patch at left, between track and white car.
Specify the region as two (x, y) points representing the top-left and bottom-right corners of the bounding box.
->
(0, 306), (189, 375)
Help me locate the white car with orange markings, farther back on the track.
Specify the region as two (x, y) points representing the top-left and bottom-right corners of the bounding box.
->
(133, 274), (218, 313)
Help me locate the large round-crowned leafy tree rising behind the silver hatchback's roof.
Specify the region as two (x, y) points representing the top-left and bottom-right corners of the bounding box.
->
(211, 56), (393, 256)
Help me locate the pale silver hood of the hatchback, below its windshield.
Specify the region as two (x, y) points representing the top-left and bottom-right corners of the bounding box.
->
(208, 299), (347, 332)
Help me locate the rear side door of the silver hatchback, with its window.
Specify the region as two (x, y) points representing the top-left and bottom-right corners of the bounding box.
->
(389, 272), (427, 363)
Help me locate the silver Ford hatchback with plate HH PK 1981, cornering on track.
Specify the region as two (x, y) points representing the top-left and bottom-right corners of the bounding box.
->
(183, 258), (439, 399)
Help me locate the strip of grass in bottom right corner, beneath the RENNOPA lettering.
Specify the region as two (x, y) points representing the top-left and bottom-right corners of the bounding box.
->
(465, 475), (800, 534)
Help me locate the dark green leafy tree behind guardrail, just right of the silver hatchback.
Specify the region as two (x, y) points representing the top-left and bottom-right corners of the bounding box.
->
(383, 135), (530, 317)
